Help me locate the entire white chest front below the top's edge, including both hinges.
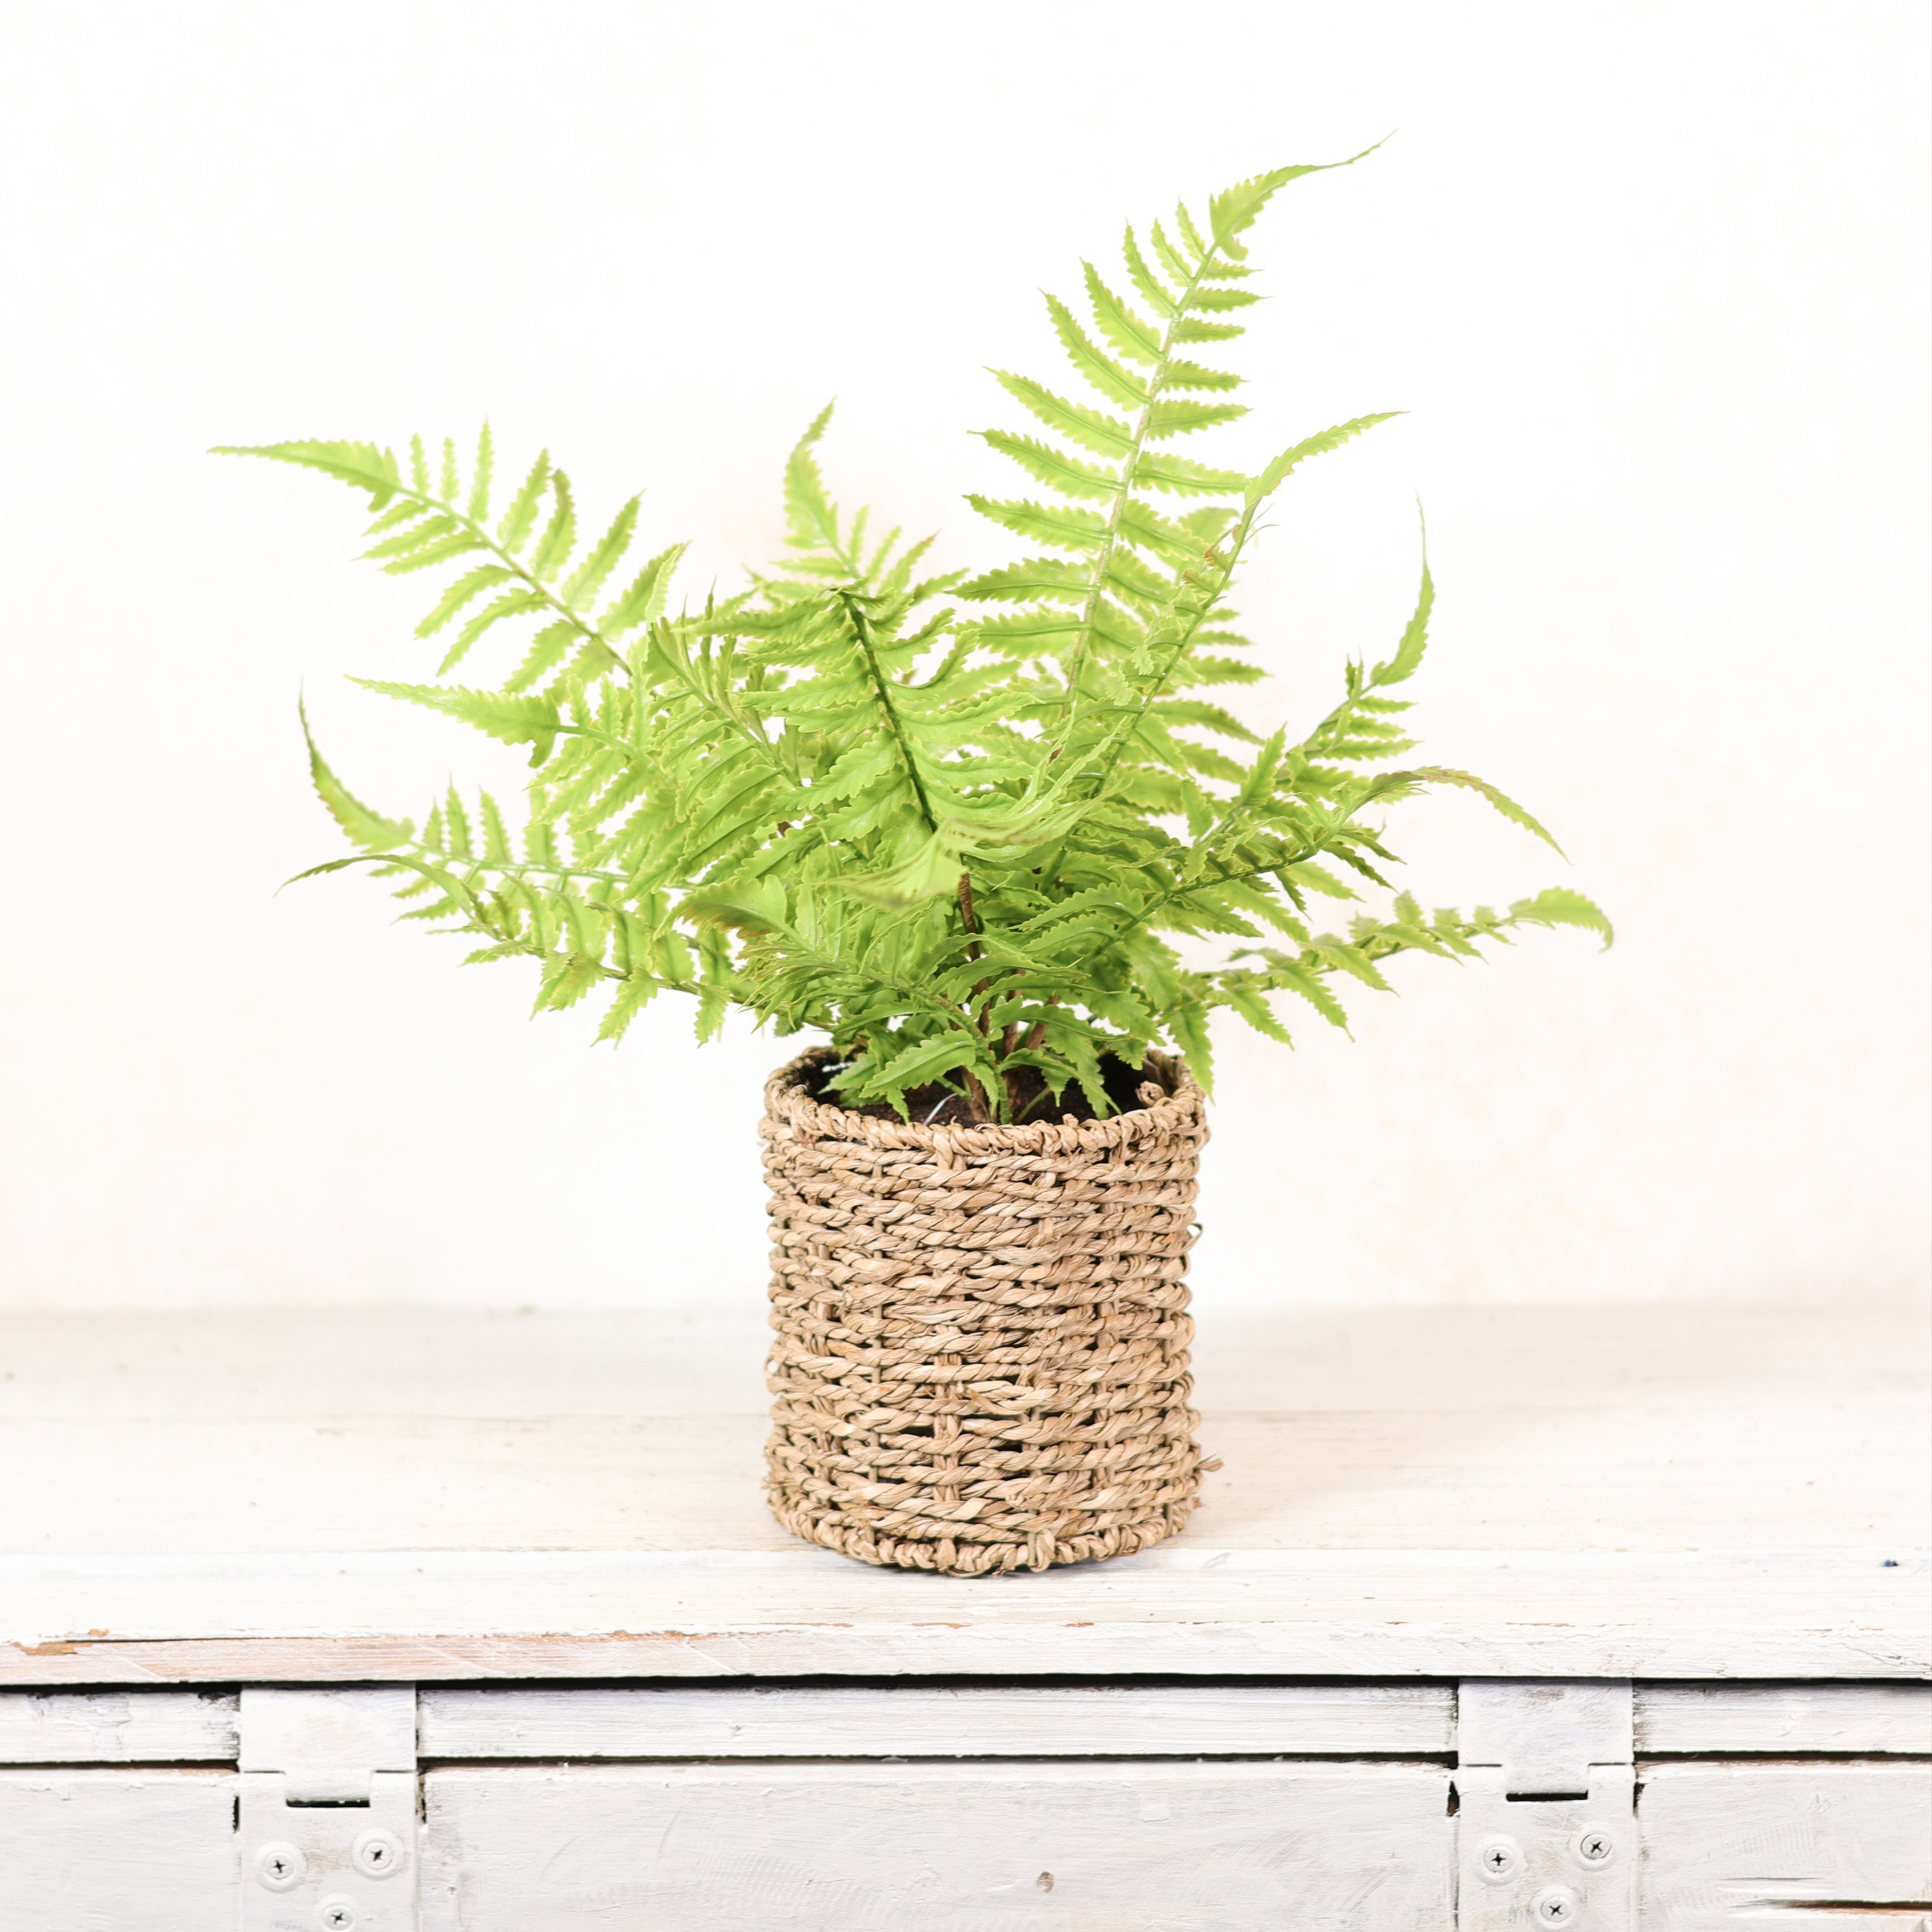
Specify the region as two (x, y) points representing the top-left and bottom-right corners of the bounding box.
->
(0, 1681), (1932, 1932)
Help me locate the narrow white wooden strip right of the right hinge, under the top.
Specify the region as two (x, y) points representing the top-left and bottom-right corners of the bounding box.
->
(1636, 1685), (1932, 1756)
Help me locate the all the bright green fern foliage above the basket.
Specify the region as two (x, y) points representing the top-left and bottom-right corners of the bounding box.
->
(243, 156), (1613, 1119)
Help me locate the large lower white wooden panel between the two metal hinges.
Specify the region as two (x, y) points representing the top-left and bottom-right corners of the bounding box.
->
(423, 1764), (1453, 1932)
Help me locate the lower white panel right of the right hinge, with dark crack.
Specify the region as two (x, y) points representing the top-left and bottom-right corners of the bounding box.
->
(1636, 1764), (1932, 1932)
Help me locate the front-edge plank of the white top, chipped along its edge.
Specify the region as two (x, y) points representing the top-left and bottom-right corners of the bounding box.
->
(0, 1544), (1932, 1683)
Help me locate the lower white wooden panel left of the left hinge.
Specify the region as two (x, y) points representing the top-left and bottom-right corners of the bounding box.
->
(0, 1770), (238, 1932)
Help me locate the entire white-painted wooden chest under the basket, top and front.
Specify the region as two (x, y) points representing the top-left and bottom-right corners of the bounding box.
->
(0, 1308), (1932, 1932)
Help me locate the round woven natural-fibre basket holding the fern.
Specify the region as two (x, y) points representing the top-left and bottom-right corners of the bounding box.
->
(759, 1049), (1208, 1576)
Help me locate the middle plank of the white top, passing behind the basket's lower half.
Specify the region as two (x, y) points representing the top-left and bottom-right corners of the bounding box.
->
(0, 1399), (1926, 1557)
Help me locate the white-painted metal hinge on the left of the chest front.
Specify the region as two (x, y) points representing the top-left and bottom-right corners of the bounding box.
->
(237, 1685), (419, 1932)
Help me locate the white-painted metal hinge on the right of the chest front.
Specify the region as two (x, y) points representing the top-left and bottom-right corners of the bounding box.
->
(1455, 1679), (1636, 1932)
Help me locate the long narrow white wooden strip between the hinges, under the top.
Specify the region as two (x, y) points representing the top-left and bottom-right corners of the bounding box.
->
(417, 1685), (1455, 1762)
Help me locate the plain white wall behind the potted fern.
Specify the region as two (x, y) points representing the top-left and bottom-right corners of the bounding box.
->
(0, 0), (1926, 1306)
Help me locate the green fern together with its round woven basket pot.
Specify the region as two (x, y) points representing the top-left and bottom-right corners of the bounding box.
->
(219, 156), (1610, 1575)
